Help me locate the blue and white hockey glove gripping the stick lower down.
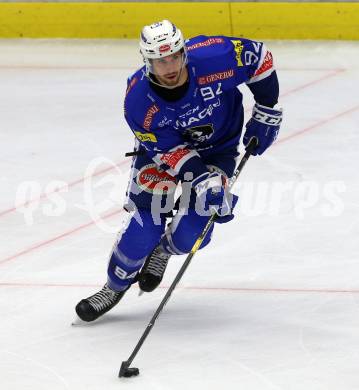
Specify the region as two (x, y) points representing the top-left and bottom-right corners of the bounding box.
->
(192, 172), (238, 223)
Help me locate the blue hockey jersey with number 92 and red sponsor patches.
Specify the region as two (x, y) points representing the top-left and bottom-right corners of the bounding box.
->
(125, 35), (274, 175)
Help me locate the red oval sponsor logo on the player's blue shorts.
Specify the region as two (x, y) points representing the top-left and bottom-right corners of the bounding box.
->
(136, 164), (177, 195)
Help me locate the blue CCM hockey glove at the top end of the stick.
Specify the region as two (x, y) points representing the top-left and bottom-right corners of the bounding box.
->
(243, 103), (283, 156)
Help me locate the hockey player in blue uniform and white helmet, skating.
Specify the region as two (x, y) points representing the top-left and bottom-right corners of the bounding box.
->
(76, 20), (282, 321)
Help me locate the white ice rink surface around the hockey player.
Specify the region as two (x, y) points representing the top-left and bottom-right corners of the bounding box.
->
(0, 40), (359, 390)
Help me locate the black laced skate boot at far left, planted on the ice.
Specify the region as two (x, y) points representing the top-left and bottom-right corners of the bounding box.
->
(75, 283), (128, 322)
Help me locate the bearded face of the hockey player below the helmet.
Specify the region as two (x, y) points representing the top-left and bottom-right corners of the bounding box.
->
(152, 52), (187, 86)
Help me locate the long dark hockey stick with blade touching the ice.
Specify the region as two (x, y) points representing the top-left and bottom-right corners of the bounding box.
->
(118, 137), (258, 378)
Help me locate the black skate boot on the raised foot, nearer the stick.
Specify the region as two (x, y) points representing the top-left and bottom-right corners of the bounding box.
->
(138, 245), (171, 292)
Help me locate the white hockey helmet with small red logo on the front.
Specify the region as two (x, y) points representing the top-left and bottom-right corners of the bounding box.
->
(140, 20), (186, 69)
